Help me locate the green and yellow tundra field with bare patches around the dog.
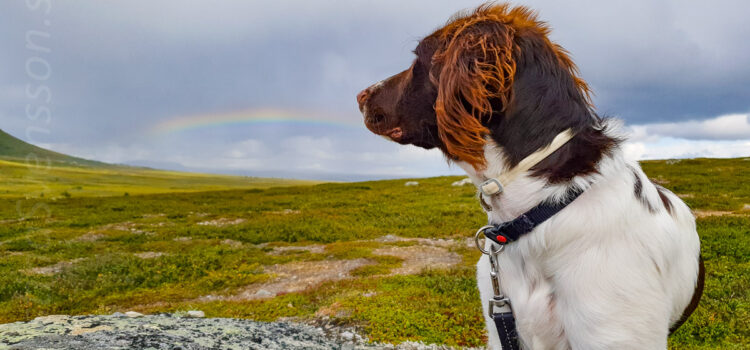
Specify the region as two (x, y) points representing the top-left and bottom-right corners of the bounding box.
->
(0, 159), (750, 349)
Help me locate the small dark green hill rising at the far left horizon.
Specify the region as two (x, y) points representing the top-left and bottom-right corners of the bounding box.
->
(0, 130), (111, 167)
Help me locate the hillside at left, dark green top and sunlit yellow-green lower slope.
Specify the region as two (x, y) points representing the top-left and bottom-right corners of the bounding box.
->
(0, 130), (320, 200)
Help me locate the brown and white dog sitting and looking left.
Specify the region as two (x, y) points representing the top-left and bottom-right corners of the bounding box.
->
(357, 5), (704, 349)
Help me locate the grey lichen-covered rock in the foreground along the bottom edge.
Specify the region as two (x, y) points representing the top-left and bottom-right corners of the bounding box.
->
(0, 311), (472, 350)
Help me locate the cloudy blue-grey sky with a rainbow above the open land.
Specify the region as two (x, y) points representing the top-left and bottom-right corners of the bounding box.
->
(0, 0), (750, 181)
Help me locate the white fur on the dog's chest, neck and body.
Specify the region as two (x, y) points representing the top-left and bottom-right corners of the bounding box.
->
(459, 121), (700, 350)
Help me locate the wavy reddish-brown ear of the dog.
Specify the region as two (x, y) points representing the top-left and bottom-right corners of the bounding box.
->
(431, 18), (516, 170)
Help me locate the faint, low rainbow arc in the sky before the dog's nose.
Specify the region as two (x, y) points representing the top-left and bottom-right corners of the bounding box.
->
(148, 109), (362, 135)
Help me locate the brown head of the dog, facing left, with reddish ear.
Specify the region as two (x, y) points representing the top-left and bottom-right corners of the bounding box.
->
(357, 5), (590, 174)
